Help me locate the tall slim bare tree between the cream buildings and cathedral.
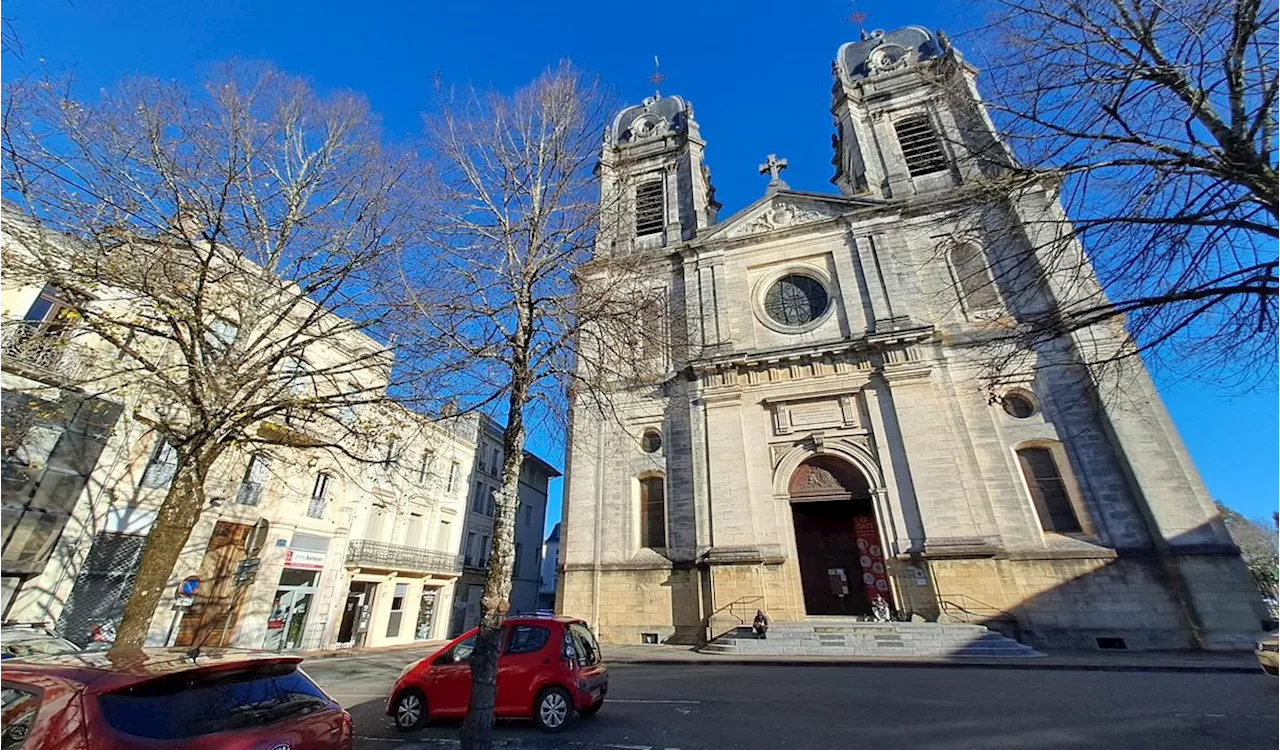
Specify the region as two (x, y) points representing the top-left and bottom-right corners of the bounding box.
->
(391, 65), (666, 749)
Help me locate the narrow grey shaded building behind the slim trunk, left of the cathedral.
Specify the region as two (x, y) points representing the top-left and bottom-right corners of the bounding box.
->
(449, 415), (561, 635)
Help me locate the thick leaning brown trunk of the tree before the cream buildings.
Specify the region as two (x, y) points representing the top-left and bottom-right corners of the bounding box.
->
(111, 451), (212, 653)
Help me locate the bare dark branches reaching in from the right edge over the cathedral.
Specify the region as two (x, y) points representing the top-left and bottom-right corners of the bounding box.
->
(973, 0), (1280, 383)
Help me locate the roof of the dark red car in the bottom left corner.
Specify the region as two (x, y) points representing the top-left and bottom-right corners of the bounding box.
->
(0, 649), (302, 692)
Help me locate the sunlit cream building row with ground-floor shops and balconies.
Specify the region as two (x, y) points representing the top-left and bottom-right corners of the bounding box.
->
(0, 216), (476, 650)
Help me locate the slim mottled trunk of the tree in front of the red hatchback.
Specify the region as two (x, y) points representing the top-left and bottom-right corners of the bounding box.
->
(462, 360), (531, 750)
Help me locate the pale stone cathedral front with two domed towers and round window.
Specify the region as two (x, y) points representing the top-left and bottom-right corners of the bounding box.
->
(557, 27), (1262, 649)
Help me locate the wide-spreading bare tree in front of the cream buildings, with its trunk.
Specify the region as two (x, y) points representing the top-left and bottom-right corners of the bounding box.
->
(0, 65), (420, 649)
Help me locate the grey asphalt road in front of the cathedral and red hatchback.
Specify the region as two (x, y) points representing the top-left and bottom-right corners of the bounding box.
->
(303, 645), (1280, 750)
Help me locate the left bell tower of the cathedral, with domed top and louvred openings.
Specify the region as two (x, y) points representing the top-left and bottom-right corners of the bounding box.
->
(596, 93), (719, 255)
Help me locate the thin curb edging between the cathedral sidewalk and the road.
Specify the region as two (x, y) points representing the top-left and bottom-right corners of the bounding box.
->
(605, 657), (1262, 674)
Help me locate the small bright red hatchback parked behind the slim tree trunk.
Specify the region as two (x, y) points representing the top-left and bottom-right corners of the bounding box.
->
(387, 617), (609, 732)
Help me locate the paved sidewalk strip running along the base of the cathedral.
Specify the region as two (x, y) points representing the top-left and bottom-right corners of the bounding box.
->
(600, 644), (1261, 674)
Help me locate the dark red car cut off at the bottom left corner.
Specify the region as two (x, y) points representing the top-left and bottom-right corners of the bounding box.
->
(0, 649), (353, 750)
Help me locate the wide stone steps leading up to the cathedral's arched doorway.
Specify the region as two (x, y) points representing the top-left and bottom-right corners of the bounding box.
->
(701, 617), (1043, 658)
